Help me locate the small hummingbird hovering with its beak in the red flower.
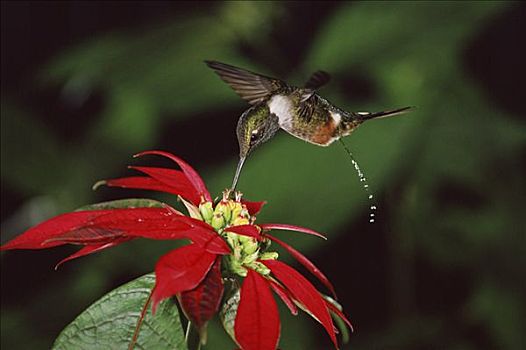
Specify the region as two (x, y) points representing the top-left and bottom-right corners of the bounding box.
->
(205, 61), (411, 191)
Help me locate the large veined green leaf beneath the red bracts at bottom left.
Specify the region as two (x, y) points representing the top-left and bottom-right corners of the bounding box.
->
(53, 274), (186, 349)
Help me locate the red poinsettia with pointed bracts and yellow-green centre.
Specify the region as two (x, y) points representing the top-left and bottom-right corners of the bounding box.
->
(0, 151), (351, 350)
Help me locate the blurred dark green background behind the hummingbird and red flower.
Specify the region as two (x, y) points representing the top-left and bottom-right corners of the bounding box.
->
(1, 1), (526, 350)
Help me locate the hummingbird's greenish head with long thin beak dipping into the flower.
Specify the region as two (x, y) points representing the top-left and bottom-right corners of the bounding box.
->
(232, 102), (279, 191)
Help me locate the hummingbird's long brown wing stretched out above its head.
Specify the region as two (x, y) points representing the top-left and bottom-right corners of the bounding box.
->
(205, 61), (287, 105)
